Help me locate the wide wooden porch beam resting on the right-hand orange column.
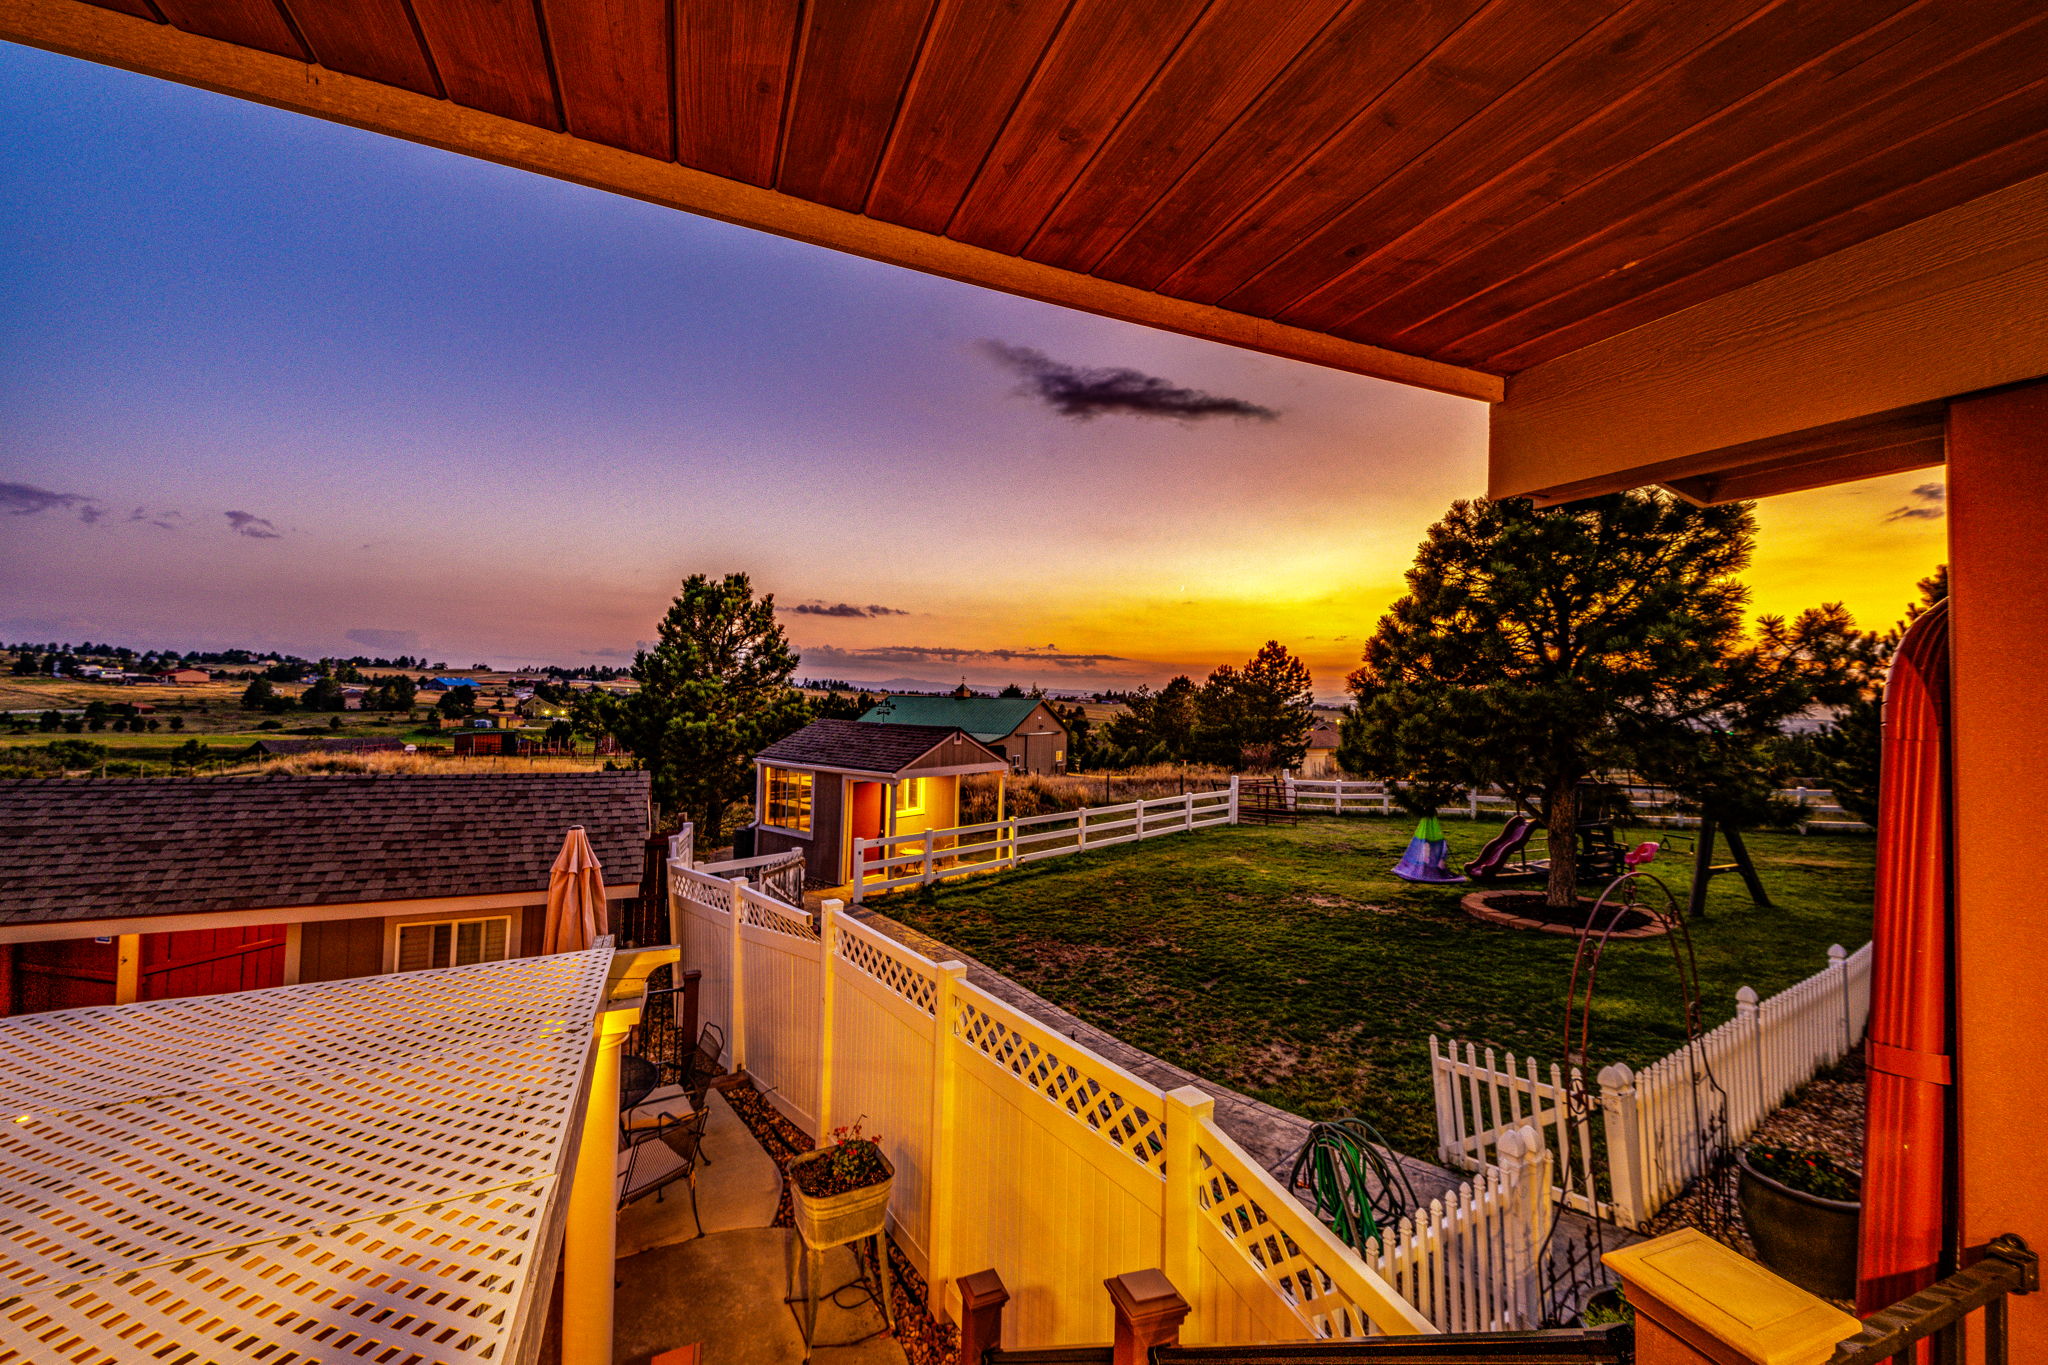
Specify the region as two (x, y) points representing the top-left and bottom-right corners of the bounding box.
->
(1489, 162), (2048, 501)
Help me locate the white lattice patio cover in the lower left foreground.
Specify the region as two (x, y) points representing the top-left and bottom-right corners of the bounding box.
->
(0, 941), (612, 1365)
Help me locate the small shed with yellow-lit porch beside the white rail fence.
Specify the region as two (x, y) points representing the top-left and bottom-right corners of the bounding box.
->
(754, 720), (1010, 886)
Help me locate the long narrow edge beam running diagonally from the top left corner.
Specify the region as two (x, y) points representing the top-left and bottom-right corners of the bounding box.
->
(0, 0), (1503, 403)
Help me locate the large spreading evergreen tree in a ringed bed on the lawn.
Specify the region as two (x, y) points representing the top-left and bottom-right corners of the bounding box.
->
(1339, 491), (1839, 907)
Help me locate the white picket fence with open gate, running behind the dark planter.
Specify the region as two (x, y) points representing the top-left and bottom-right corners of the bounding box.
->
(1430, 943), (1870, 1228)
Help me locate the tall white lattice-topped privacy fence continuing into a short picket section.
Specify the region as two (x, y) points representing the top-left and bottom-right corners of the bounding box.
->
(670, 862), (1550, 1349)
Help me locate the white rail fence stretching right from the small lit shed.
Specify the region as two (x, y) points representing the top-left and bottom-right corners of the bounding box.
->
(854, 778), (1237, 905)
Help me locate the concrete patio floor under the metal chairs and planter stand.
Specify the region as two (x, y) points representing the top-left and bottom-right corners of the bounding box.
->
(612, 1091), (905, 1365)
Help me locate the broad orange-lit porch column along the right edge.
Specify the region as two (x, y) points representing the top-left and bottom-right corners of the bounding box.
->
(1948, 381), (2048, 1361)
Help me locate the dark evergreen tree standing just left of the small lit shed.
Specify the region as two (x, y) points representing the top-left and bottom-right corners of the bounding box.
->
(586, 573), (809, 845)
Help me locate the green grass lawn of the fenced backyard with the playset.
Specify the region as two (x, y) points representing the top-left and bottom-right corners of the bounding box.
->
(877, 817), (1874, 1156)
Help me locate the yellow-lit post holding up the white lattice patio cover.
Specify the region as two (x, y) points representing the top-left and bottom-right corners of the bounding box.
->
(561, 999), (641, 1365)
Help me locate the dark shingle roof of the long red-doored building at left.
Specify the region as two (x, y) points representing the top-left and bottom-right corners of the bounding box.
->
(0, 772), (649, 925)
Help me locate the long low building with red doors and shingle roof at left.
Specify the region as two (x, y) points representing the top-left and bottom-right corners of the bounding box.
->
(0, 773), (649, 1013)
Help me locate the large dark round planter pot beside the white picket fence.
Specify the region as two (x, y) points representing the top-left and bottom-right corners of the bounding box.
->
(1735, 1142), (1864, 1300)
